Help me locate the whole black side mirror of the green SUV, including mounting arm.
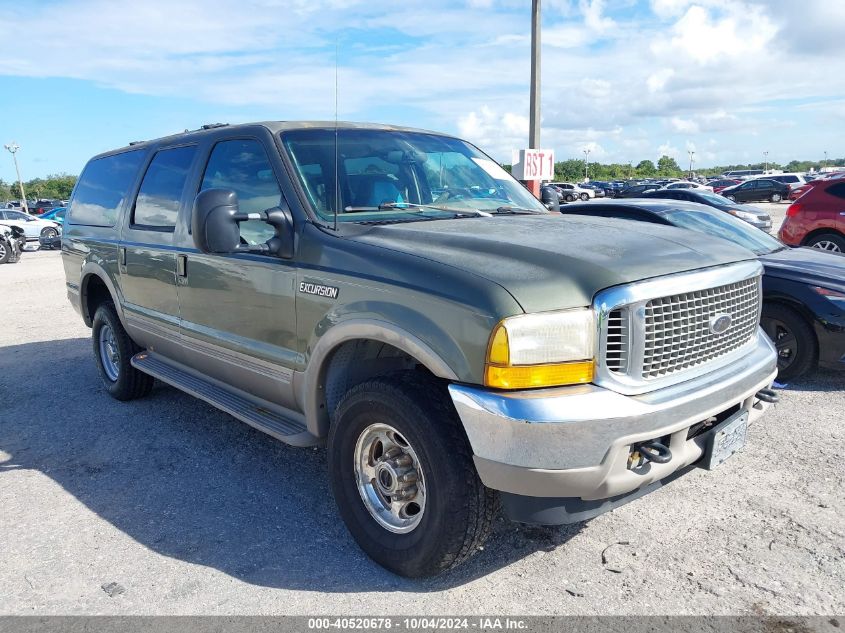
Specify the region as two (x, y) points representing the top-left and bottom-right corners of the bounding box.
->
(191, 189), (294, 258)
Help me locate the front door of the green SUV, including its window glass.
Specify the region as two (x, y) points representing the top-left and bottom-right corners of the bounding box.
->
(172, 138), (302, 408)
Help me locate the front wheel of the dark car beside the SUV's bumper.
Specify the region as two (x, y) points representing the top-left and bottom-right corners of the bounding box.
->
(760, 303), (818, 380)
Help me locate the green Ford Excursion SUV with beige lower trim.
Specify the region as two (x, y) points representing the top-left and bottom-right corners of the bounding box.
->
(62, 122), (777, 576)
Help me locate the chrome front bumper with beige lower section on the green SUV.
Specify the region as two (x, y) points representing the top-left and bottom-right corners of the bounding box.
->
(449, 328), (777, 500)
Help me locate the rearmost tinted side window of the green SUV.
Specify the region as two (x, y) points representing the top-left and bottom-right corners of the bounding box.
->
(67, 150), (144, 226)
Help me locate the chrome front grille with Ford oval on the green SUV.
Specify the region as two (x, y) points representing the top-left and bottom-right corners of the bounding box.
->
(595, 261), (762, 394)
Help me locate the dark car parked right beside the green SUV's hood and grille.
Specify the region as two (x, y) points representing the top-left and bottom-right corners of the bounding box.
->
(561, 199), (845, 380)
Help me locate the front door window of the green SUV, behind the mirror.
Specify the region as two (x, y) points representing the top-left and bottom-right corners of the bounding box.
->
(200, 139), (282, 244)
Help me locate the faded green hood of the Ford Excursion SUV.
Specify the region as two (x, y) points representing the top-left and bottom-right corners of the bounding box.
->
(350, 214), (754, 312)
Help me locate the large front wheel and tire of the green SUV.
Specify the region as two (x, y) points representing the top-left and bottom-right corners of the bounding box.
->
(328, 371), (496, 578)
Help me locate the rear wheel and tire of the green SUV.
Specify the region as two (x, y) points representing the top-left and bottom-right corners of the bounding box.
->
(91, 301), (153, 400)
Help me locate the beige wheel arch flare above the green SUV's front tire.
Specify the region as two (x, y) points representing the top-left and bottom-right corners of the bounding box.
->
(294, 318), (458, 437)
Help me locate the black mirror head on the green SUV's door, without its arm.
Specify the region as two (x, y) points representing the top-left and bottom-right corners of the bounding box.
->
(191, 189), (241, 254)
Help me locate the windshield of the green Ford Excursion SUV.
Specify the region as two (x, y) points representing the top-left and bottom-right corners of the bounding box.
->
(282, 129), (548, 222)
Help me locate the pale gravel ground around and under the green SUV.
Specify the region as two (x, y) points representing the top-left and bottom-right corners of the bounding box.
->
(0, 246), (845, 615)
